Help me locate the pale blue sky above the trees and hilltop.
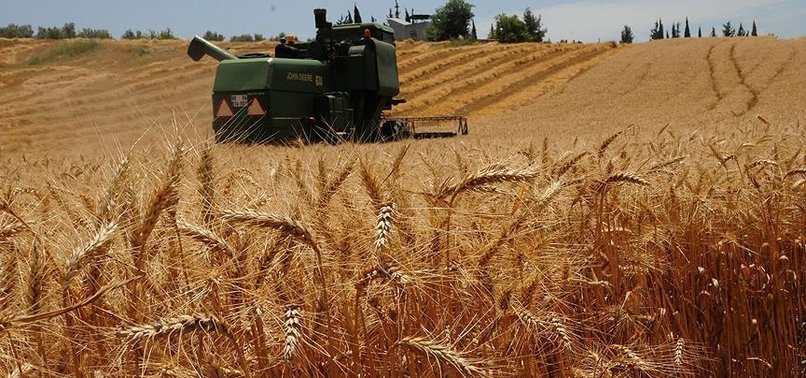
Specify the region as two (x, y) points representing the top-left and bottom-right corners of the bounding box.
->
(0, 0), (806, 42)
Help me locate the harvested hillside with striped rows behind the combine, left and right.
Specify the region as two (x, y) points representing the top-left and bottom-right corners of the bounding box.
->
(0, 40), (616, 150)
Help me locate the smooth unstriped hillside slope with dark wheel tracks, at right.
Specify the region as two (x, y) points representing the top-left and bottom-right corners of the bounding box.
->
(477, 38), (806, 139)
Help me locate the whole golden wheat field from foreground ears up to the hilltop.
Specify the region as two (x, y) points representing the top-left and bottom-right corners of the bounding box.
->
(0, 38), (806, 377)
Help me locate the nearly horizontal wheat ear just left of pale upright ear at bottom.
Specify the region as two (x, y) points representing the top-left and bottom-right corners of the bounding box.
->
(118, 314), (227, 340)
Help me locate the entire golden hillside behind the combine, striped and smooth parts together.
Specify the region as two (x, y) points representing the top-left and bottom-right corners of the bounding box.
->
(0, 38), (806, 152)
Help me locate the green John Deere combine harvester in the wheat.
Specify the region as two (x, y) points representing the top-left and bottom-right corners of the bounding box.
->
(188, 9), (467, 143)
